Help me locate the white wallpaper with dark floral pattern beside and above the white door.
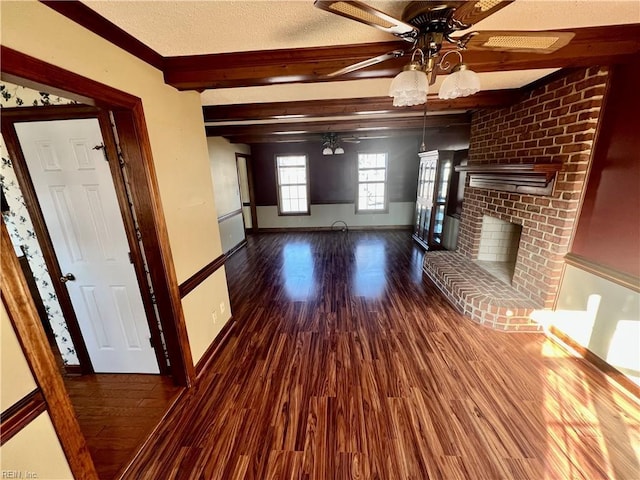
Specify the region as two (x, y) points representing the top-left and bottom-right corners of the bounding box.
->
(0, 83), (79, 365)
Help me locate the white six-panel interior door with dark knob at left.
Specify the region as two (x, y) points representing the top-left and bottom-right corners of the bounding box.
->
(15, 118), (159, 373)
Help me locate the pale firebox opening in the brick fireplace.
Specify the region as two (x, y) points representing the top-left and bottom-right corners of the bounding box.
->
(476, 215), (522, 285)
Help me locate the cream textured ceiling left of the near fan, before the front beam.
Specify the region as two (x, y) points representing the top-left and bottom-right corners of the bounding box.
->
(84, 0), (406, 56)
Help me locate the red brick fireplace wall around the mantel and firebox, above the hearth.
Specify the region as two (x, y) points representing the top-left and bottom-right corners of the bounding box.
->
(458, 67), (608, 308)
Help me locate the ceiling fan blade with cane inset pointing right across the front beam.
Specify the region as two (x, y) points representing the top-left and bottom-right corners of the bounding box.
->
(458, 30), (575, 53)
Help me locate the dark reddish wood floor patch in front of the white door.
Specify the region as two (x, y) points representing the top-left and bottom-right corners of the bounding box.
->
(65, 374), (181, 480)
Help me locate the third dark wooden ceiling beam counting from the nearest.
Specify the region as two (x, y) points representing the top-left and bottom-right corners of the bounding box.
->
(206, 113), (471, 141)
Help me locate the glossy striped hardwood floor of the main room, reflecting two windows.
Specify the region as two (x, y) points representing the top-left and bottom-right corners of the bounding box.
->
(125, 232), (640, 480)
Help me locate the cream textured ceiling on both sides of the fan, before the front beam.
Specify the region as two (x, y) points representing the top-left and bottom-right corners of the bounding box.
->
(84, 0), (640, 56)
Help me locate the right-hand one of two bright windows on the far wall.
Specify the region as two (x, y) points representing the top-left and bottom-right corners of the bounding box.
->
(356, 153), (387, 212)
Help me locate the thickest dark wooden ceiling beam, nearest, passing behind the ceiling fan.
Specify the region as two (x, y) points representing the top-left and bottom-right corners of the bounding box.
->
(164, 24), (640, 90)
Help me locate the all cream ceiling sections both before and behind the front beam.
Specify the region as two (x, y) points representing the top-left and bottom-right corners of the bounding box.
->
(84, 0), (640, 105)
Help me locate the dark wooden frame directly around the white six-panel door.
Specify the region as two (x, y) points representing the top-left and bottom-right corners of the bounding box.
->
(2, 105), (169, 375)
